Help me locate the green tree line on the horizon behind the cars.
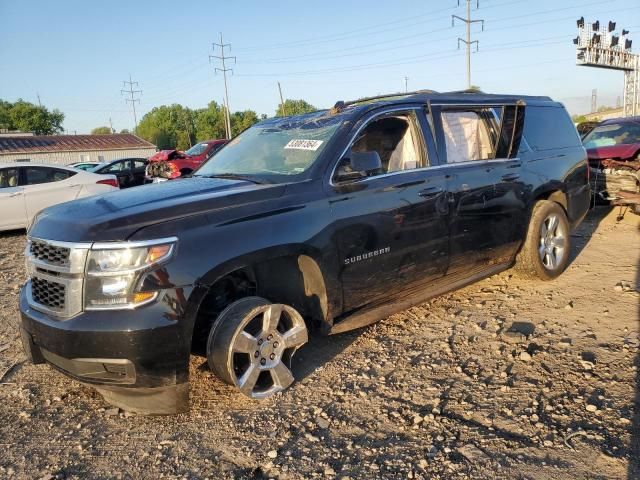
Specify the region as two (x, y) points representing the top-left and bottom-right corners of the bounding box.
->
(0, 99), (316, 150)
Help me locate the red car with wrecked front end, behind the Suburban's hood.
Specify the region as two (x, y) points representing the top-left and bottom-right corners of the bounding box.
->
(145, 140), (228, 183)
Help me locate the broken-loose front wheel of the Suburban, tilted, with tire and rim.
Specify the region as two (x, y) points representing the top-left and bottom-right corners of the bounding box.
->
(207, 297), (308, 399)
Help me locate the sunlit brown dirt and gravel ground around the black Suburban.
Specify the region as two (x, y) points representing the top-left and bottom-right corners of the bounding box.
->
(0, 209), (640, 479)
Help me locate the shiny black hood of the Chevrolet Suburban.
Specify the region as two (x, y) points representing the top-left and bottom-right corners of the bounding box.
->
(29, 178), (286, 242)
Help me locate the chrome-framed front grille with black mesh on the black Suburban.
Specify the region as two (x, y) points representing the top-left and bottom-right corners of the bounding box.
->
(25, 238), (91, 320)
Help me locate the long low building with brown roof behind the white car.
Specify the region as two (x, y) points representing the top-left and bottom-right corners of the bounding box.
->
(0, 133), (156, 165)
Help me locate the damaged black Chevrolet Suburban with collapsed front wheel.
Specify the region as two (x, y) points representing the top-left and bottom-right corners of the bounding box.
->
(20, 91), (590, 413)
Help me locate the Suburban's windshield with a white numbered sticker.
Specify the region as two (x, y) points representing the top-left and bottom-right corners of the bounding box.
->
(194, 112), (344, 180)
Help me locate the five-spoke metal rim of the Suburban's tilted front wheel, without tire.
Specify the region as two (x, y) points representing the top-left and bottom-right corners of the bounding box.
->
(229, 304), (308, 399)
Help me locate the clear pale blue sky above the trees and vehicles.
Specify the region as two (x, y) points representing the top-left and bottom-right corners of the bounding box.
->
(0, 0), (640, 134)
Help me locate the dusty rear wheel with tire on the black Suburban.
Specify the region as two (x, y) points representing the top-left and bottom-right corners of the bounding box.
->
(516, 200), (571, 280)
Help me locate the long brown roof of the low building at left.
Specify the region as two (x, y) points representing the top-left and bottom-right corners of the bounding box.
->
(0, 133), (156, 155)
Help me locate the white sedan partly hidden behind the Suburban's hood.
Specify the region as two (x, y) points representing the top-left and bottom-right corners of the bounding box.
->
(0, 162), (119, 231)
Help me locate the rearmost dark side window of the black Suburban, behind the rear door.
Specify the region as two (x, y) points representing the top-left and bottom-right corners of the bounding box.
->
(524, 107), (582, 151)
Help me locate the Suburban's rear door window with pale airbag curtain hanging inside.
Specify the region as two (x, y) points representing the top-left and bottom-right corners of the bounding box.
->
(442, 108), (497, 163)
